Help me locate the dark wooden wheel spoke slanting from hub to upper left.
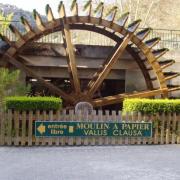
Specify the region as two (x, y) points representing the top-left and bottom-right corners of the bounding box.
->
(4, 53), (74, 104)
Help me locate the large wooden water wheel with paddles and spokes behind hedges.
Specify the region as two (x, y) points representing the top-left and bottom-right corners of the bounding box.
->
(1, 1), (180, 107)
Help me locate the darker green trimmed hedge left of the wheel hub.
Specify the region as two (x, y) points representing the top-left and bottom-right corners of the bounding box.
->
(6, 96), (62, 110)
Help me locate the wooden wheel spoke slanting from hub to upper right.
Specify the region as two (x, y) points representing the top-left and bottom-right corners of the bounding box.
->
(87, 21), (140, 97)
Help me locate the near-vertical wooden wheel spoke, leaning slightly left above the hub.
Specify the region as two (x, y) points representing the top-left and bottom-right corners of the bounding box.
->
(62, 20), (81, 94)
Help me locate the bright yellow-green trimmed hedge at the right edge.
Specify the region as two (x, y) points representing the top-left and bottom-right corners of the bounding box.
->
(123, 99), (180, 114)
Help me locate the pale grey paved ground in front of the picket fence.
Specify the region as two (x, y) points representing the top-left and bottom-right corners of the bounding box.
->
(0, 145), (180, 180)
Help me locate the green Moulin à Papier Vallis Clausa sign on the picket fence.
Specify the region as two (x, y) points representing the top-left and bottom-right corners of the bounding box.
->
(35, 121), (152, 137)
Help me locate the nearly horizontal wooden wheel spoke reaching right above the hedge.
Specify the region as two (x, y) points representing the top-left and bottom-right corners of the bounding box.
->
(92, 88), (167, 107)
